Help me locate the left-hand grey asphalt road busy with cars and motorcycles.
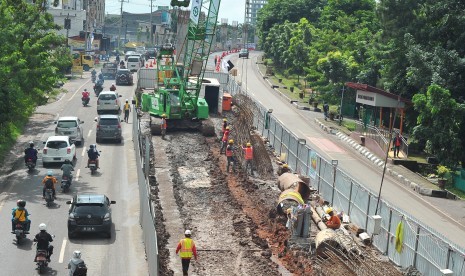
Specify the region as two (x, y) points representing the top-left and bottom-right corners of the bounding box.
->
(0, 70), (148, 275)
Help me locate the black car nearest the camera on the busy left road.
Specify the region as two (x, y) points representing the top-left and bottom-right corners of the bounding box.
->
(66, 194), (116, 239)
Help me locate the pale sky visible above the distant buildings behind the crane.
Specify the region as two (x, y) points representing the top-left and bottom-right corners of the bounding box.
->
(105, 0), (245, 24)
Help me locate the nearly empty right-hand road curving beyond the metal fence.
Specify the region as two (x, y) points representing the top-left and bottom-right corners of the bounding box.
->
(227, 51), (465, 248)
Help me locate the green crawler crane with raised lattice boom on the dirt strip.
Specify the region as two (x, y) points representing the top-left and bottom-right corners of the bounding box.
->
(141, 0), (221, 136)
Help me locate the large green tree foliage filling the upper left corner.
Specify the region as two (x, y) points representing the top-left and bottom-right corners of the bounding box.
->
(0, 0), (67, 152)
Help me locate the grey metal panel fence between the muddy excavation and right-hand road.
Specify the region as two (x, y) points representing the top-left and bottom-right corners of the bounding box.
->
(204, 71), (465, 276)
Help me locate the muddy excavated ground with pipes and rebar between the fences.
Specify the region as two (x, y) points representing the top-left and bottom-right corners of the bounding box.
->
(135, 94), (406, 275)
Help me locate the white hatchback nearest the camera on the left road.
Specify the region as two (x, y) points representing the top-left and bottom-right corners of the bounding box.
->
(42, 136), (76, 167)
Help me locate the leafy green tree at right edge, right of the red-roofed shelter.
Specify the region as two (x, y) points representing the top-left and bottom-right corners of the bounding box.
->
(413, 84), (465, 167)
